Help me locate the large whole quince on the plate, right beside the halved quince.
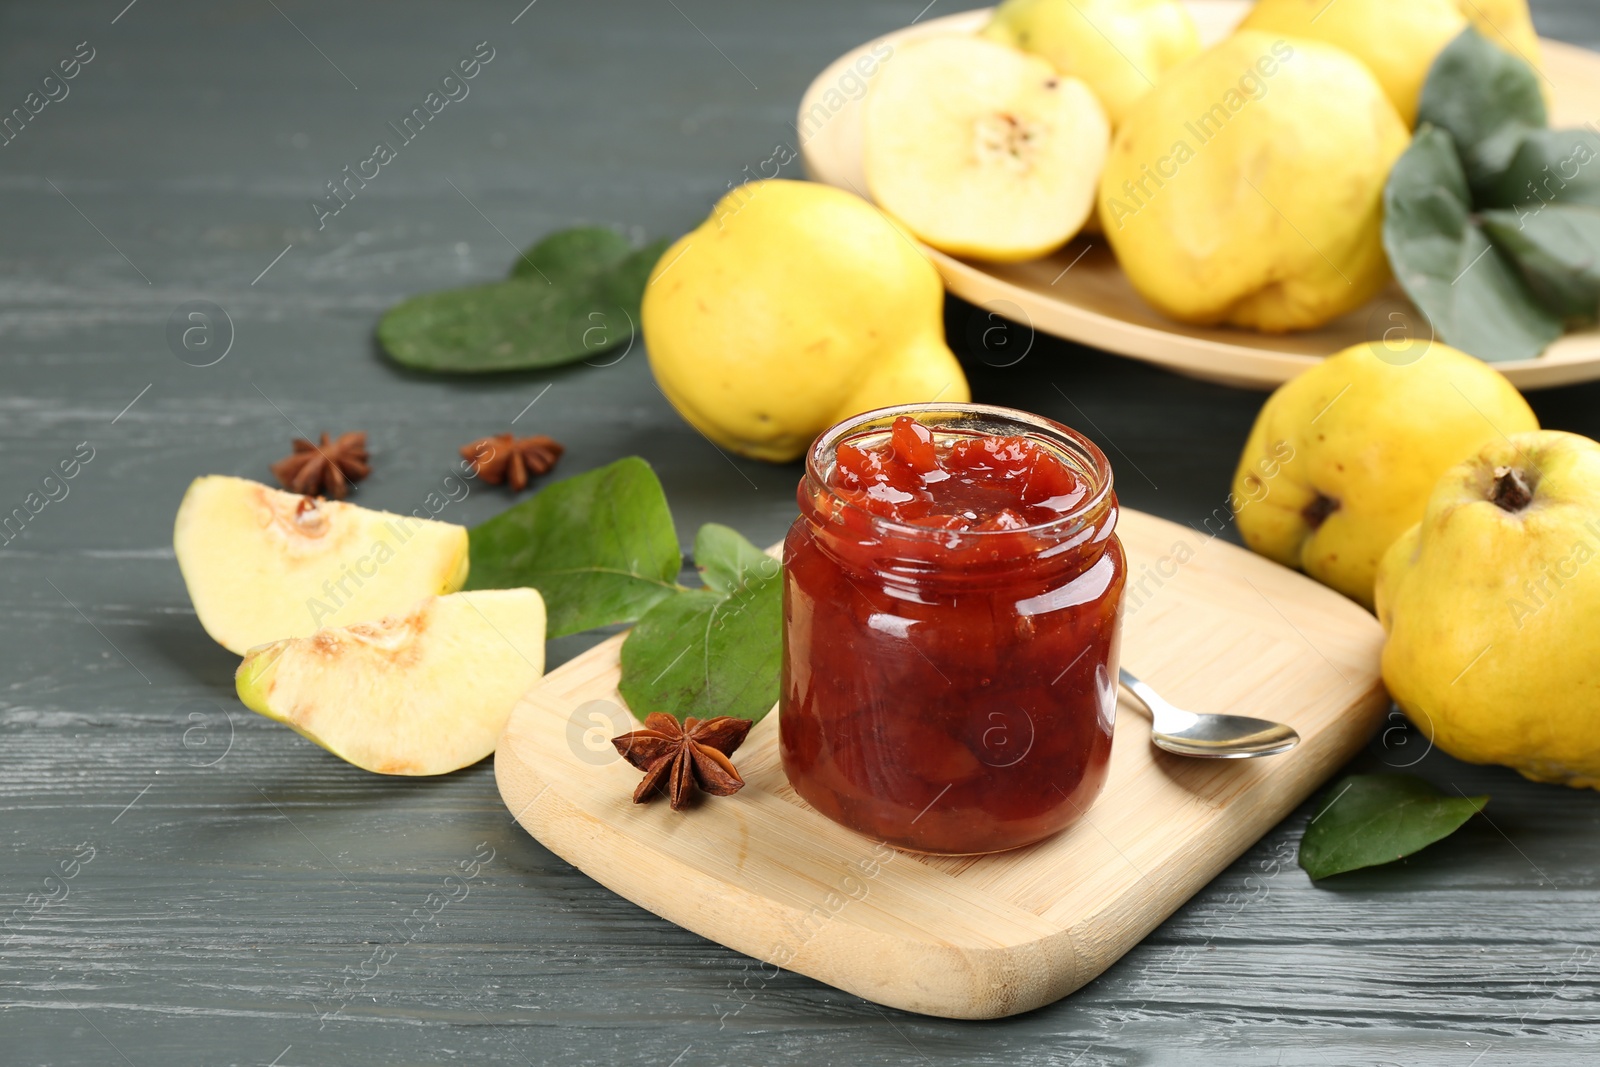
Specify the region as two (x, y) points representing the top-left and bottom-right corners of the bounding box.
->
(1099, 32), (1408, 333)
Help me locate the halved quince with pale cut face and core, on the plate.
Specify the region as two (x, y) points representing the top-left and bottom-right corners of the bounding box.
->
(864, 37), (1110, 262)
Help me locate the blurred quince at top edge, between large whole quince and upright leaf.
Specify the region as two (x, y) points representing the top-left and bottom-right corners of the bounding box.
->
(1240, 0), (1467, 126)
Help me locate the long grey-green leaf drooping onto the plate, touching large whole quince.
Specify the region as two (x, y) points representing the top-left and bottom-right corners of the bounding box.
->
(1384, 126), (1562, 362)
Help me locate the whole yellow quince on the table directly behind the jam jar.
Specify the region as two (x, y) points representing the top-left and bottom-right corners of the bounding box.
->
(642, 181), (971, 462)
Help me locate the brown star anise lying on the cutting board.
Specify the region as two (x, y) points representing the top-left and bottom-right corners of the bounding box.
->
(611, 712), (750, 811)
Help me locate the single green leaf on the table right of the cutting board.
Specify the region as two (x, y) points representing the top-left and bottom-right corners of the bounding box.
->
(1299, 774), (1490, 878)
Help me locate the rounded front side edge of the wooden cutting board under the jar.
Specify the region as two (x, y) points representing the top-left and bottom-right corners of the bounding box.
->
(494, 662), (1389, 1019)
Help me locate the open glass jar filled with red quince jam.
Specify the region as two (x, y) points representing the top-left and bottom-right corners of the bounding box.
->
(779, 405), (1126, 854)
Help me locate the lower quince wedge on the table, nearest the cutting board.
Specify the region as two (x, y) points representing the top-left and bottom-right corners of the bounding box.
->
(234, 589), (544, 774)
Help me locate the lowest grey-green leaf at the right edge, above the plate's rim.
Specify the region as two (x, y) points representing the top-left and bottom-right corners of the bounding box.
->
(1483, 203), (1600, 323)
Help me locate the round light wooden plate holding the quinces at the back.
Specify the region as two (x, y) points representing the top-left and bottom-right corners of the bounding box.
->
(795, 0), (1600, 389)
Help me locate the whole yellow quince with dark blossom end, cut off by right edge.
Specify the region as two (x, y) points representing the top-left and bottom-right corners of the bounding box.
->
(1378, 430), (1600, 789)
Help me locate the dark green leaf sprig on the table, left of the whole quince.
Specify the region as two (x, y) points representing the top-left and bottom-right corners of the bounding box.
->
(378, 227), (666, 374)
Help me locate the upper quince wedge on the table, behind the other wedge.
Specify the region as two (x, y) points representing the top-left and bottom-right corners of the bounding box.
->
(173, 475), (467, 656)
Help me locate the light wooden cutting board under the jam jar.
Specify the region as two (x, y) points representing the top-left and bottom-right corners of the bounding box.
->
(494, 510), (1389, 1019)
